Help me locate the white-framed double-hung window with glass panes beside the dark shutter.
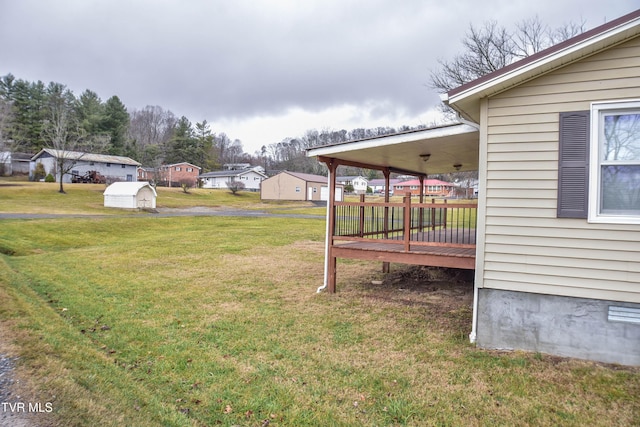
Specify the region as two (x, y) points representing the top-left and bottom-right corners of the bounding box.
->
(589, 100), (640, 224)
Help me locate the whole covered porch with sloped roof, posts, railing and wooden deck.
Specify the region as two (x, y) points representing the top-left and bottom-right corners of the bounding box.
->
(307, 123), (479, 293)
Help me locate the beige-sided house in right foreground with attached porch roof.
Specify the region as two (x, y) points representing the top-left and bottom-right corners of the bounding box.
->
(308, 10), (640, 365)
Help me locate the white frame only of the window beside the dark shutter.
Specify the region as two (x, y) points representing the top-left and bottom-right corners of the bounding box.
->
(587, 99), (640, 224)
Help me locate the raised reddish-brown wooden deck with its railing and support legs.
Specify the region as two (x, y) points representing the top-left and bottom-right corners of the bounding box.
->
(327, 195), (477, 292)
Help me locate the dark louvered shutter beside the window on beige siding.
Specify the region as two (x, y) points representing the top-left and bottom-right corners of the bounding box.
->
(558, 111), (590, 218)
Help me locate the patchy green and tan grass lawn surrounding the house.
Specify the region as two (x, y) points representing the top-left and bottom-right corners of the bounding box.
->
(0, 184), (640, 426)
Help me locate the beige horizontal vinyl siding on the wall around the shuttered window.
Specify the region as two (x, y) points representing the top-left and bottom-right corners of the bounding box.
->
(479, 38), (640, 303)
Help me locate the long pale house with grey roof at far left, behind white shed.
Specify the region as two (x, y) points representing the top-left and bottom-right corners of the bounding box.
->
(29, 148), (140, 182)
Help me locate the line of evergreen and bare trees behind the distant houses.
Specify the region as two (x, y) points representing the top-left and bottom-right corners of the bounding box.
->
(0, 74), (430, 174)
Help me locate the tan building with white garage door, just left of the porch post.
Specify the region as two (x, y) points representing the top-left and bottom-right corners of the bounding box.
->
(260, 171), (343, 201)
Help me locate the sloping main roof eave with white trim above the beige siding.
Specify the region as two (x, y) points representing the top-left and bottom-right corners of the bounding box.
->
(440, 10), (640, 123)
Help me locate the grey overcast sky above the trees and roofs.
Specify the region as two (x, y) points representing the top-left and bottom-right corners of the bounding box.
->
(0, 0), (640, 153)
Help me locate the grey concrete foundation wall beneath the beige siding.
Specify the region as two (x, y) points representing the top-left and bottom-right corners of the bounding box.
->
(477, 289), (640, 366)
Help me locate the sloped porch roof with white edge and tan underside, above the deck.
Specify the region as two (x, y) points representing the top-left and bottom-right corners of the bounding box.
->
(307, 123), (479, 176)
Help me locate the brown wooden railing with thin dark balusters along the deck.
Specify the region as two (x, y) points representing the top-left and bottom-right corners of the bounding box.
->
(333, 194), (478, 251)
